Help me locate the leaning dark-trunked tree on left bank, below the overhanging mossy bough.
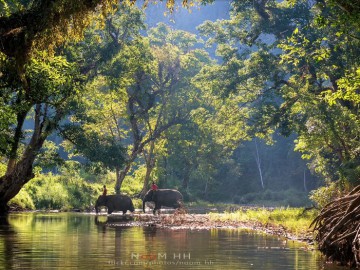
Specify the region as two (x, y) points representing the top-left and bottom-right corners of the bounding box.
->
(0, 52), (79, 211)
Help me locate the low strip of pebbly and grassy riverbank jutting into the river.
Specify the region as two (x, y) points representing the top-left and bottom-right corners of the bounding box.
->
(100, 208), (316, 244)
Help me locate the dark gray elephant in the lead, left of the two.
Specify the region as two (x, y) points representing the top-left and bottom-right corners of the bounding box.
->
(95, 195), (135, 215)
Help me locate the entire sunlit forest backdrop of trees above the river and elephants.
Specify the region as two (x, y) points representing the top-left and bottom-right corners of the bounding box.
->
(0, 0), (360, 266)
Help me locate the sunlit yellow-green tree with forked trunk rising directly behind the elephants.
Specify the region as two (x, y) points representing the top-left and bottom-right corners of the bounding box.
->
(65, 24), (209, 193)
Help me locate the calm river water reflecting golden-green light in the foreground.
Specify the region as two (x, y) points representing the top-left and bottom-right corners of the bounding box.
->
(0, 213), (345, 270)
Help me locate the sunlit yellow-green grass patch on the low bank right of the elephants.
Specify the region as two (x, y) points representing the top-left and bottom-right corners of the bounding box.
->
(209, 207), (317, 236)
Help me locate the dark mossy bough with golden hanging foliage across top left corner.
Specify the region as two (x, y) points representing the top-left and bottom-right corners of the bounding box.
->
(0, 0), (201, 62)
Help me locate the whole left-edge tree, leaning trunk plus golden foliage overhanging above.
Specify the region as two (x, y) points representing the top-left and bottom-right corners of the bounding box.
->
(0, 0), (183, 212)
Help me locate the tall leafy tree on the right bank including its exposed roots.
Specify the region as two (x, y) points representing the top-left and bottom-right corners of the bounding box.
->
(200, 0), (360, 266)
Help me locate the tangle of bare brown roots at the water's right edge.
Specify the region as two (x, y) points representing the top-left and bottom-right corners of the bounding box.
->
(312, 185), (360, 268)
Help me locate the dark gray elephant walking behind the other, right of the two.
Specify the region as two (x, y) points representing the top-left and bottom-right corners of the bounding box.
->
(143, 189), (183, 215)
